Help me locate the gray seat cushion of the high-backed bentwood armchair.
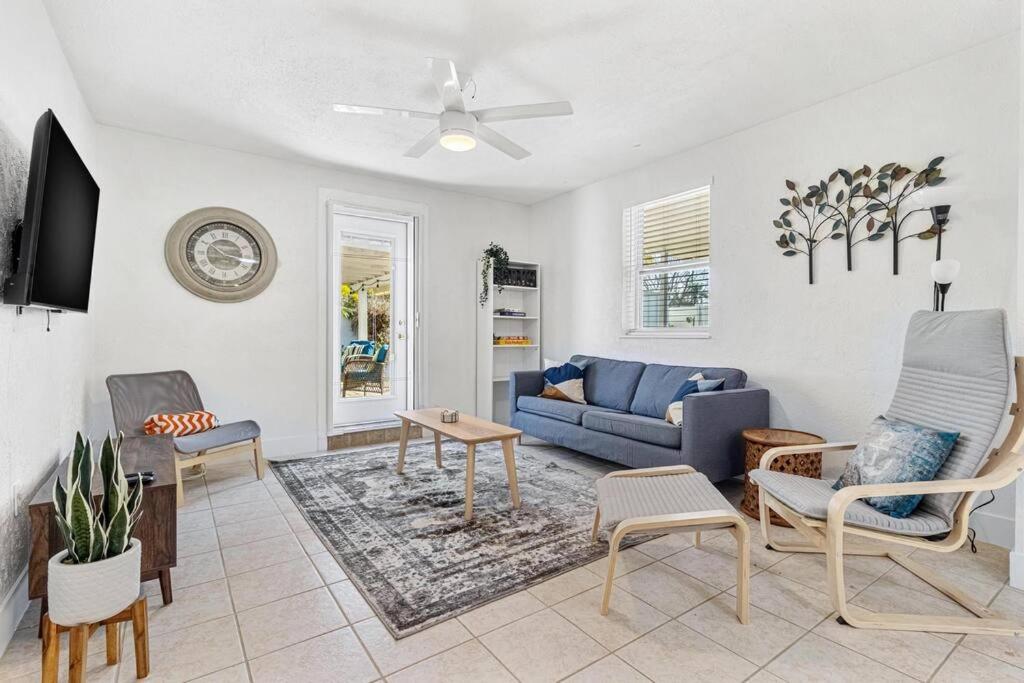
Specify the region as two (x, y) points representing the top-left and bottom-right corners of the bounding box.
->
(751, 469), (951, 536)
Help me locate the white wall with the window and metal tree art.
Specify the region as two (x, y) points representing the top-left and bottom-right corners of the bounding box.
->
(531, 35), (1020, 545)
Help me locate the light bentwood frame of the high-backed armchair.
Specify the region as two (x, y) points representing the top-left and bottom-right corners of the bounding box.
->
(759, 356), (1024, 636)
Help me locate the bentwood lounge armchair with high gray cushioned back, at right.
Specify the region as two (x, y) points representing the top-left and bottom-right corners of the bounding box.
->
(751, 310), (1024, 636)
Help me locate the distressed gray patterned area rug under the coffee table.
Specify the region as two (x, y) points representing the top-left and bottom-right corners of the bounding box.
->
(273, 441), (646, 638)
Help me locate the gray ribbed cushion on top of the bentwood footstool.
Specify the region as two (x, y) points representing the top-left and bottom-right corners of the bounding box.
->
(597, 472), (735, 530)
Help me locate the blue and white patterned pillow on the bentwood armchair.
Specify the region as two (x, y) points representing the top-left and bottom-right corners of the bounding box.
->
(833, 415), (959, 519)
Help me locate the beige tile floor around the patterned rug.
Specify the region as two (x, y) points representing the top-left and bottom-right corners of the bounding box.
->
(0, 444), (1024, 683)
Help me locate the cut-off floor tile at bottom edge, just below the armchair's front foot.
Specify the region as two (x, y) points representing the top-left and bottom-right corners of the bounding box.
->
(766, 633), (913, 683)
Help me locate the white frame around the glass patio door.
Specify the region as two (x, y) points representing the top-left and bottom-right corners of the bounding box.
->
(315, 187), (430, 451)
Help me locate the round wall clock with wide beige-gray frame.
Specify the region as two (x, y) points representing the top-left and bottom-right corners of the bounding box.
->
(164, 207), (278, 303)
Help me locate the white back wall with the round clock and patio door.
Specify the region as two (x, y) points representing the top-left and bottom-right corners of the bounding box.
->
(89, 126), (529, 455)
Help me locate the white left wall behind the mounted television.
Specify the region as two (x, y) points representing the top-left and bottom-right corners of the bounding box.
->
(0, 0), (102, 652)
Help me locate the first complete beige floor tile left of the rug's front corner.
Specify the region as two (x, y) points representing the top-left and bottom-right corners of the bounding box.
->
(238, 588), (346, 659)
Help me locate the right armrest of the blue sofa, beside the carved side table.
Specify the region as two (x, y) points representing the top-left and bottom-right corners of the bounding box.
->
(681, 388), (769, 481)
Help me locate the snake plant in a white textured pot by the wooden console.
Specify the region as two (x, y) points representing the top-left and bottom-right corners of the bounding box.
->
(46, 432), (142, 626)
